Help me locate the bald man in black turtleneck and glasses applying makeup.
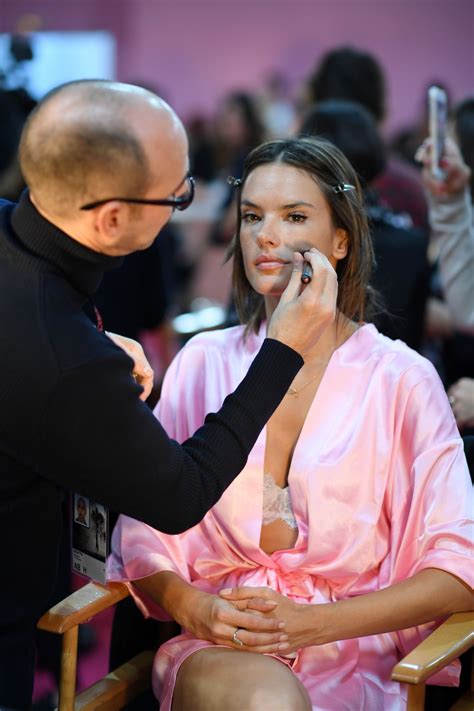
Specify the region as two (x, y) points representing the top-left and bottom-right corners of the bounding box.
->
(0, 81), (337, 710)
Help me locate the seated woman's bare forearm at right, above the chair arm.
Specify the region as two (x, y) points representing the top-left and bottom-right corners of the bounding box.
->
(308, 568), (473, 644)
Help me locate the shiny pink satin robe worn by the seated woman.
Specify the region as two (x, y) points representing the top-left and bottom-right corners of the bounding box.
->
(109, 325), (473, 711)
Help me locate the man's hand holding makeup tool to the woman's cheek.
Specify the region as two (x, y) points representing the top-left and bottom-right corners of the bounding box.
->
(267, 248), (337, 358)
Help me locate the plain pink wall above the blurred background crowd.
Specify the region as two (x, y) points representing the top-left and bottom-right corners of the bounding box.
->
(0, 0), (474, 136)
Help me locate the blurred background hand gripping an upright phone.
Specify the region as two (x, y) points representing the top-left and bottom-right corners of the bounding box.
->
(415, 138), (471, 196)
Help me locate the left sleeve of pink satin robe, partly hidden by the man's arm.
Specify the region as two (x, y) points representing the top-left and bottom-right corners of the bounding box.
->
(107, 346), (213, 620)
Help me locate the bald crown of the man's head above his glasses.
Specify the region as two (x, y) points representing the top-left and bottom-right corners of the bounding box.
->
(20, 81), (184, 217)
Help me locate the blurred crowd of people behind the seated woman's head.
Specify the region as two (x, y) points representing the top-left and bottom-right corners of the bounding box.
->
(174, 47), (474, 433)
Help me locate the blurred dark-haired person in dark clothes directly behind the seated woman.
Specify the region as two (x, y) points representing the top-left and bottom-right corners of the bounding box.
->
(300, 100), (429, 351)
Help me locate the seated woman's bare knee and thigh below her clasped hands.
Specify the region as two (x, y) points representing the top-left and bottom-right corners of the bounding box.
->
(172, 647), (312, 711)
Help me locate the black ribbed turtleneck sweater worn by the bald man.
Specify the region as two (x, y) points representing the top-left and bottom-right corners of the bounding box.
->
(0, 192), (303, 676)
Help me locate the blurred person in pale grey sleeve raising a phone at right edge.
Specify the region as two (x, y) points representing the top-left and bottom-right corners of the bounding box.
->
(417, 103), (474, 434)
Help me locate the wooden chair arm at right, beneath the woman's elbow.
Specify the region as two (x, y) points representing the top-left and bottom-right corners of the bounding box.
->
(392, 612), (474, 684)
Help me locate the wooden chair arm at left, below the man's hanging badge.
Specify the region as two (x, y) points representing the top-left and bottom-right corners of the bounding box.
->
(38, 583), (129, 634)
